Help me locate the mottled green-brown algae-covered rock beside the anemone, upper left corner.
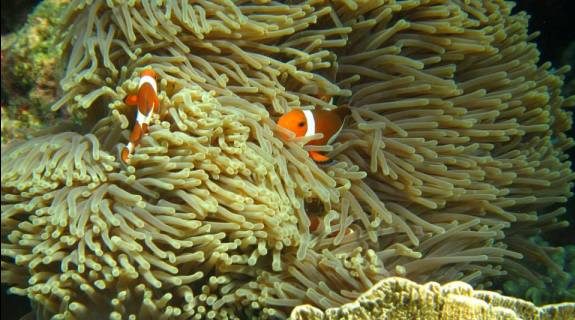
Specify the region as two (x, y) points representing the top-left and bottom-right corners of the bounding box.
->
(1, 0), (69, 143)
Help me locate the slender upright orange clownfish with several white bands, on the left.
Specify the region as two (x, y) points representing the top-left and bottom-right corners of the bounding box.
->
(121, 69), (160, 164)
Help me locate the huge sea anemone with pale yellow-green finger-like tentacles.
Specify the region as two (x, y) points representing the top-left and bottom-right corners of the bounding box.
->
(2, 0), (575, 319)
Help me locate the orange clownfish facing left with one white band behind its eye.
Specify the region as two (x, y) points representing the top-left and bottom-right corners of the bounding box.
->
(277, 106), (350, 162)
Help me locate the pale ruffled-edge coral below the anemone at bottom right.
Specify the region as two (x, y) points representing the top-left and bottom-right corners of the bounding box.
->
(291, 278), (575, 320)
